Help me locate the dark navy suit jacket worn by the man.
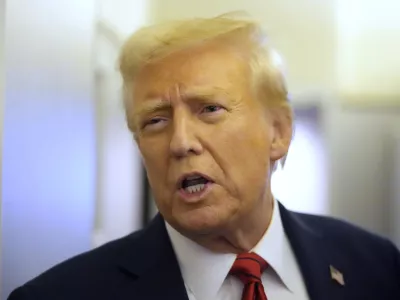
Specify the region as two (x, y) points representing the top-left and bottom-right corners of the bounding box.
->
(9, 205), (400, 300)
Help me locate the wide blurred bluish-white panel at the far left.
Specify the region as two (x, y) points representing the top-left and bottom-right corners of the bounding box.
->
(1, 0), (96, 299)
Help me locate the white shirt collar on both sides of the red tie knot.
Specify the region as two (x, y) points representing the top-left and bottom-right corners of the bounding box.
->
(166, 200), (294, 300)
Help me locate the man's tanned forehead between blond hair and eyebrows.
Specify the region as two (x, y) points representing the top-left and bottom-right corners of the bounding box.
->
(133, 43), (249, 102)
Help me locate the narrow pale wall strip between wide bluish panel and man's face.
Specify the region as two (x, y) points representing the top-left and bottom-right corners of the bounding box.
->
(93, 0), (148, 246)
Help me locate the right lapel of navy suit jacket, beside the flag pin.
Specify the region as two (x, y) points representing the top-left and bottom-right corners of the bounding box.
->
(279, 204), (346, 300)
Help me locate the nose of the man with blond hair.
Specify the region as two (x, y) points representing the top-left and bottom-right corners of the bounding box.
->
(170, 114), (203, 158)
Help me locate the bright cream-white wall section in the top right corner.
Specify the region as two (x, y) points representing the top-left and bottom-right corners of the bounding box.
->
(336, 0), (400, 103)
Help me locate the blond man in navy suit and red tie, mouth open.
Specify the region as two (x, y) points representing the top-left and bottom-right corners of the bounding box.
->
(9, 16), (400, 300)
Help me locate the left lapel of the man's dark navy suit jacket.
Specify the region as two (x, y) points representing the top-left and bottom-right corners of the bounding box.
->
(115, 215), (188, 300)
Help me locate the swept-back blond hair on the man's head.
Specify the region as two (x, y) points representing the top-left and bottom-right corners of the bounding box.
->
(119, 13), (291, 166)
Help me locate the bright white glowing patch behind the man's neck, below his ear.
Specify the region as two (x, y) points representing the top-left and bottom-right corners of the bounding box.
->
(271, 106), (329, 215)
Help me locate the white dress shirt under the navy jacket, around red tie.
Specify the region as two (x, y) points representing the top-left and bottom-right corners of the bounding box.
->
(166, 200), (309, 300)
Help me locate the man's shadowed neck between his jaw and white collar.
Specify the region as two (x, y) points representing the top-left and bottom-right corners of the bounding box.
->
(192, 193), (274, 254)
